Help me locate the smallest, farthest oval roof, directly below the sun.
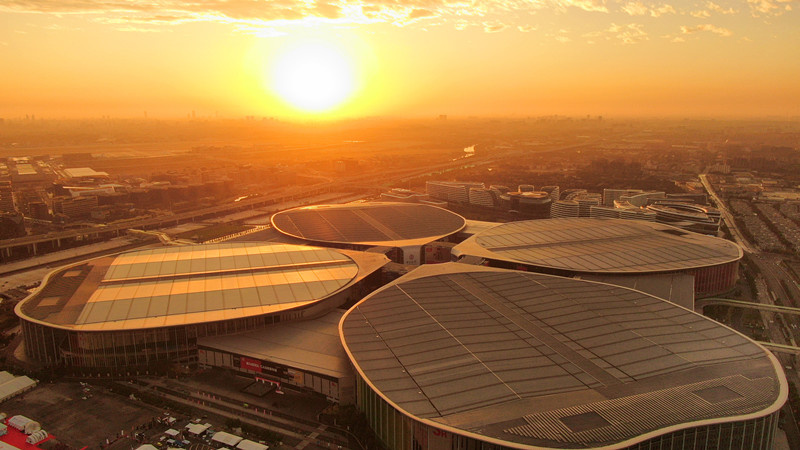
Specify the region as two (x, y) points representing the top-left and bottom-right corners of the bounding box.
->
(272, 203), (465, 247)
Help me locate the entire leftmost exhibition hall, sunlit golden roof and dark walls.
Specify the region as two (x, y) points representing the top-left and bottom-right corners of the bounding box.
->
(16, 243), (388, 376)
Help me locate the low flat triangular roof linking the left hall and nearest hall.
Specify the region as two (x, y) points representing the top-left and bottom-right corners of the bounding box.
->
(198, 309), (353, 378)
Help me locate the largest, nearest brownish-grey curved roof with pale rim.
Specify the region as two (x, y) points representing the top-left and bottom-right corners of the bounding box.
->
(340, 263), (786, 448)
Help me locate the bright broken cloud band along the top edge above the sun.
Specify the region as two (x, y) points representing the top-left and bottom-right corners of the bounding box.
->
(0, 0), (536, 32)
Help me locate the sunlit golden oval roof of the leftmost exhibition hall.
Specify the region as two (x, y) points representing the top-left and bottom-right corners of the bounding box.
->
(19, 243), (388, 330)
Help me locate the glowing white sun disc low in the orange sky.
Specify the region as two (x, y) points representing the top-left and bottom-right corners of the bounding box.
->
(270, 42), (356, 113)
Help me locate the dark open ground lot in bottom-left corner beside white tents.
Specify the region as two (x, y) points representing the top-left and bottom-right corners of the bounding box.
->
(0, 382), (163, 448)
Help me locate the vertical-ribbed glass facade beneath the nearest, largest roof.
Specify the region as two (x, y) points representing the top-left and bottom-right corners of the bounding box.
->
(356, 375), (778, 450)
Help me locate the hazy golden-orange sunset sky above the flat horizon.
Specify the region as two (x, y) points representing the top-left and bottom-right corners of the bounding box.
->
(0, 0), (800, 118)
